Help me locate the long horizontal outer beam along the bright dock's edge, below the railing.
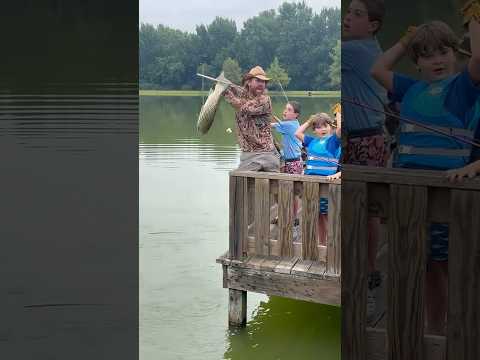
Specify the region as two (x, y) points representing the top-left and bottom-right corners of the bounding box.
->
(227, 266), (340, 305)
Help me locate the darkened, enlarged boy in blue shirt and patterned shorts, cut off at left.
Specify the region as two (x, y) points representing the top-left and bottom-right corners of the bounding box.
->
(341, 0), (389, 314)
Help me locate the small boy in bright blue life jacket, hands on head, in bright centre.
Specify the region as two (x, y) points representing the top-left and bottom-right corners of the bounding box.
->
(295, 112), (342, 245)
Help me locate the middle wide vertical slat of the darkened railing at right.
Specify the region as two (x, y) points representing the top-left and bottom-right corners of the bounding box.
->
(387, 184), (428, 360)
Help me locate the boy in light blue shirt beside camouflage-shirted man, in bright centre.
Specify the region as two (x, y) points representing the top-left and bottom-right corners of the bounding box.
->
(272, 101), (303, 174)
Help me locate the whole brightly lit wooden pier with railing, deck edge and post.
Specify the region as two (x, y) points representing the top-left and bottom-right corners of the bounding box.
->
(217, 171), (341, 326)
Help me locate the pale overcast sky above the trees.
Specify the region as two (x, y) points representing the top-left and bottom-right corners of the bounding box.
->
(140, 0), (341, 32)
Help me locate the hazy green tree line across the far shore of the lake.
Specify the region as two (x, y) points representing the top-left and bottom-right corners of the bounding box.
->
(139, 2), (341, 90)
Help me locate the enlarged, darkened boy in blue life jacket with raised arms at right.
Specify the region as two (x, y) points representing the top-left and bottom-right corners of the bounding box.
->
(372, 1), (480, 334)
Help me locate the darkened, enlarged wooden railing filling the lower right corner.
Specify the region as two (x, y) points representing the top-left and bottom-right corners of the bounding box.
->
(341, 165), (480, 360)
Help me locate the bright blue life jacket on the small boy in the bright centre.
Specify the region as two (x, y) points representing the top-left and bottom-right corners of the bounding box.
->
(304, 135), (342, 176)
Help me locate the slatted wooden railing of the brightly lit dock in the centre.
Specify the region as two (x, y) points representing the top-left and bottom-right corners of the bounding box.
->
(229, 170), (341, 275)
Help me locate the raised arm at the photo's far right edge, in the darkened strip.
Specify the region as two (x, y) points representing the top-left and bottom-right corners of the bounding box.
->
(461, 0), (480, 84)
